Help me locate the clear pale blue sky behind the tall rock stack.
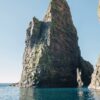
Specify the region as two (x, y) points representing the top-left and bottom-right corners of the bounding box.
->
(0, 0), (100, 83)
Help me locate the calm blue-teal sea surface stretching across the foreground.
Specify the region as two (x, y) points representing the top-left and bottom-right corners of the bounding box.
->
(0, 84), (100, 100)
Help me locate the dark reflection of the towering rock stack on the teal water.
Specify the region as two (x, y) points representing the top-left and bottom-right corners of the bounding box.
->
(20, 88), (96, 100)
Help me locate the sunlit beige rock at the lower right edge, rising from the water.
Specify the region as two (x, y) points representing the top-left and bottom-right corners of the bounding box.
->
(90, 57), (100, 89)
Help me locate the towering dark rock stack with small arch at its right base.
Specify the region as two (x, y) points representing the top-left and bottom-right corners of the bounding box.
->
(20, 0), (93, 87)
